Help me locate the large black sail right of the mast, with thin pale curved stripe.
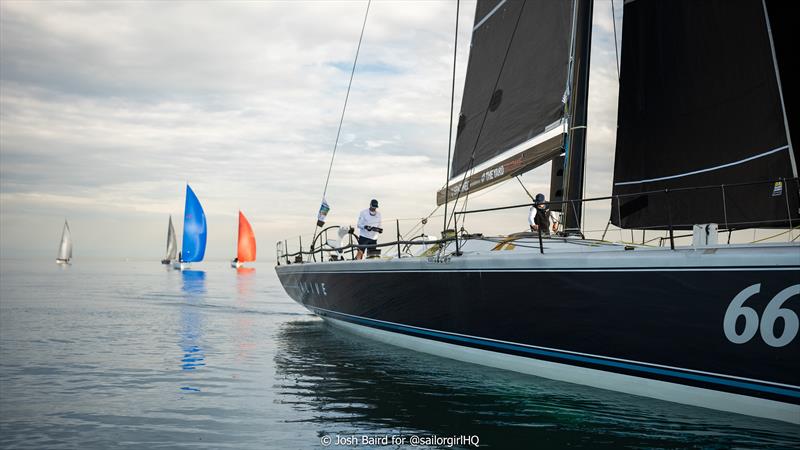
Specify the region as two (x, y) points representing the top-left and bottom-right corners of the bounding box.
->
(611, 0), (800, 229)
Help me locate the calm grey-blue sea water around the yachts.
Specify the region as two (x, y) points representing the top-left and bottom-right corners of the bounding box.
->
(0, 260), (800, 449)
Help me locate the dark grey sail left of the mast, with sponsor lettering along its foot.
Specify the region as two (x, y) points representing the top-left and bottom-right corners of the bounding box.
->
(437, 0), (573, 204)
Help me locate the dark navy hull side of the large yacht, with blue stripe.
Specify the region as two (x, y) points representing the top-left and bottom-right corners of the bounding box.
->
(277, 255), (800, 421)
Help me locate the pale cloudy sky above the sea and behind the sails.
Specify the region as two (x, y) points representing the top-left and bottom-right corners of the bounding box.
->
(0, 0), (680, 261)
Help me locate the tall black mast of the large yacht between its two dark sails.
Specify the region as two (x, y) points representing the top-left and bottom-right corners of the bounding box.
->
(563, 0), (594, 234)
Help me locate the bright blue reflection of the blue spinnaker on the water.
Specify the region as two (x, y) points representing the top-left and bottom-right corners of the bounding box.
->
(180, 270), (206, 392)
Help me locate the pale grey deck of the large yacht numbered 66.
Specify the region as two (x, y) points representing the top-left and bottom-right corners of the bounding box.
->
(276, 233), (800, 272)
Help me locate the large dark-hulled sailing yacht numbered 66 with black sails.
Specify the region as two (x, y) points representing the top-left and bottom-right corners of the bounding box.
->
(276, 0), (800, 424)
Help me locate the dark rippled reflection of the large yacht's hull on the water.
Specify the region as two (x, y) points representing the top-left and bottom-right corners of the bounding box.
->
(275, 320), (800, 448)
